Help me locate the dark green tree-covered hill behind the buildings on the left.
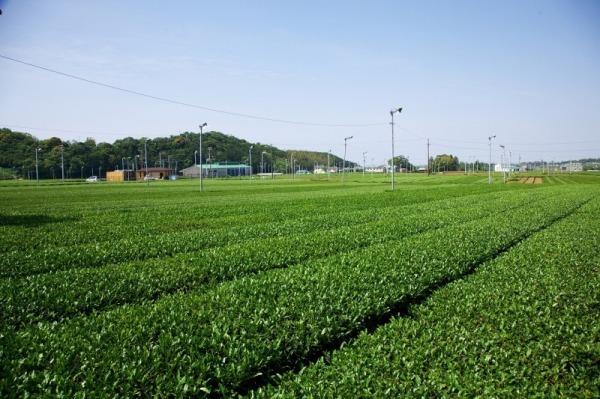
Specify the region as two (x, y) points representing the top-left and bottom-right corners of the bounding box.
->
(0, 128), (354, 177)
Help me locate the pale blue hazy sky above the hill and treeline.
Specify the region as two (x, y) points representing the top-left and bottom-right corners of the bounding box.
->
(0, 0), (600, 163)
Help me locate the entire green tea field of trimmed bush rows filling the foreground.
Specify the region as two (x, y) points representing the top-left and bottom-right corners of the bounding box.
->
(0, 174), (600, 398)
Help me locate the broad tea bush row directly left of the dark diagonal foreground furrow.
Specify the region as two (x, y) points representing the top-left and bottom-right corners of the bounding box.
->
(0, 189), (592, 396)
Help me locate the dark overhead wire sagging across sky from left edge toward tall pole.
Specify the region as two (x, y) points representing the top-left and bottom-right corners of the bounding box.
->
(0, 54), (385, 127)
